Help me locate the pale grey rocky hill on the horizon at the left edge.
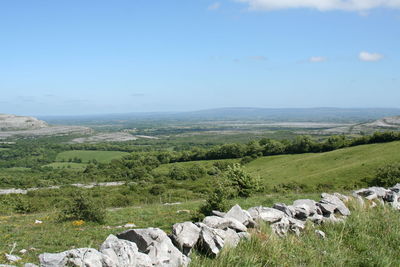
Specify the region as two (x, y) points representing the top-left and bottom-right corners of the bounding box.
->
(0, 114), (48, 131)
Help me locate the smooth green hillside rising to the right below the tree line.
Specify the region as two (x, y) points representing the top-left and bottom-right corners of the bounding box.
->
(246, 142), (400, 187)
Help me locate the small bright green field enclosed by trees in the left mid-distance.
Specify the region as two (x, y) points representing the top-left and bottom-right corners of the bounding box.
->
(56, 150), (128, 163)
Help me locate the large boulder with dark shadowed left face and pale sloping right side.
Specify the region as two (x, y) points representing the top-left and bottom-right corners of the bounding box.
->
(117, 228), (190, 267)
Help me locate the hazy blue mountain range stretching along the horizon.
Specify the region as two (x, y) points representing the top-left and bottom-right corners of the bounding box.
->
(40, 107), (400, 124)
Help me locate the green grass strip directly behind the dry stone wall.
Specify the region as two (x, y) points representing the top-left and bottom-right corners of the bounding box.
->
(0, 194), (319, 264)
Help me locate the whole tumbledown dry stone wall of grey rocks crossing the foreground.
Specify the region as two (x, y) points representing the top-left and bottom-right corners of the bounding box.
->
(0, 184), (400, 267)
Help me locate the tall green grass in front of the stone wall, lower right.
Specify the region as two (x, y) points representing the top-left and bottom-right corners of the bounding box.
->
(191, 202), (400, 267)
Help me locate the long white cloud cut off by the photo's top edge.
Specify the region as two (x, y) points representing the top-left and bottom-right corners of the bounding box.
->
(235, 0), (400, 11)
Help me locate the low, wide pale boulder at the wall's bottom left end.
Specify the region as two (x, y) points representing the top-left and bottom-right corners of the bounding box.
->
(39, 248), (117, 267)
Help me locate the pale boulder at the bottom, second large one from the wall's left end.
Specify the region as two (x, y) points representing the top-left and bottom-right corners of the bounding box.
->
(100, 235), (152, 267)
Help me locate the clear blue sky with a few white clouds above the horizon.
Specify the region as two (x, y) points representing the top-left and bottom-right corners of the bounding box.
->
(0, 0), (400, 115)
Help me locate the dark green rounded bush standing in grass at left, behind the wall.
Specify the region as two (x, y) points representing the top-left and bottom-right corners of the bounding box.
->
(59, 192), (106, 223)
